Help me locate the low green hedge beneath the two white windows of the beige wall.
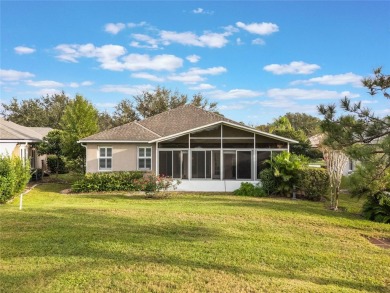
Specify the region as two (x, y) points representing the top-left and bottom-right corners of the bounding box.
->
(72, 171), (144, 193)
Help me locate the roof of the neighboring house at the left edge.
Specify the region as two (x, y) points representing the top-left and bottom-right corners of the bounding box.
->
(0, 118), (51, 142)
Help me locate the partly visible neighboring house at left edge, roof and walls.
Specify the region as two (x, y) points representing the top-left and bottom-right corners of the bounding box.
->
(0, 118), (52, 169)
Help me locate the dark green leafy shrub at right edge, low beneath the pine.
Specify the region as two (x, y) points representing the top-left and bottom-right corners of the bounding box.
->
(363, 191), (390, 223)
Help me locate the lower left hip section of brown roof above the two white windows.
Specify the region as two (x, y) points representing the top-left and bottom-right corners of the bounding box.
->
(80, 122), (159, 142)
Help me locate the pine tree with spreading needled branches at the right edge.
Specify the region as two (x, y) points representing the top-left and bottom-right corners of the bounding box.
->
(318, 68), (390, 214)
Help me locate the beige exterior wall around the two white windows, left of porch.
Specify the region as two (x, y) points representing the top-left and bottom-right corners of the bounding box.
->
(87, 143), (156, 173)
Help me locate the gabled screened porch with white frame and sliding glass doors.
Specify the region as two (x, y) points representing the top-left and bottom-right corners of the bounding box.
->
(156, 124), (289, 181)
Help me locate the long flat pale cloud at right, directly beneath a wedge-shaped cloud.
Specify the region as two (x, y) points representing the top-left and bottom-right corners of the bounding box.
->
(267, 88), (359, 100)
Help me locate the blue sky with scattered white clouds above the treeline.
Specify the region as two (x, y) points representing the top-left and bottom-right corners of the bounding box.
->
(0, 1), (390, 125)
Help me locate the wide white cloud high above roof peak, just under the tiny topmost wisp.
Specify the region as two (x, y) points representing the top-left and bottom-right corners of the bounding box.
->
(160, 31), (230, 48)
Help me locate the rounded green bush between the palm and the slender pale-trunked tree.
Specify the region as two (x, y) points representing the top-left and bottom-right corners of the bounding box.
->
(297, 168), (330, 200)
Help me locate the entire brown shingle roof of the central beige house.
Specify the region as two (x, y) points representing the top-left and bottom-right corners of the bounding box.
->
(79, 105), (296, 143)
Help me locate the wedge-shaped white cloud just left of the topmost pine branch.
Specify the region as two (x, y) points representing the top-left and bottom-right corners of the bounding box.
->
(291, 72), (363, 87)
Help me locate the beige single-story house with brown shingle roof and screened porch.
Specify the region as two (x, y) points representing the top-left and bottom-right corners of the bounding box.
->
(79, 105), (297, 191)
